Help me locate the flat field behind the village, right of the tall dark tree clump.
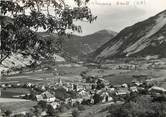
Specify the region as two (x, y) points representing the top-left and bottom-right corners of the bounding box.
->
(88, 69), (166, 85)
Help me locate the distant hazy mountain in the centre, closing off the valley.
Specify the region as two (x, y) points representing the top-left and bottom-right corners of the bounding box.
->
(40, 30), (116, 59)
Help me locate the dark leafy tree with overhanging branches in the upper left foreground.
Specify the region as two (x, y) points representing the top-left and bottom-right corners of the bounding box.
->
(0, 0), (96, 62)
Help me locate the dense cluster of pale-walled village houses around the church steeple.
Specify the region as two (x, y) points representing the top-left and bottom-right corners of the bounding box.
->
(0, 73), (166, 116)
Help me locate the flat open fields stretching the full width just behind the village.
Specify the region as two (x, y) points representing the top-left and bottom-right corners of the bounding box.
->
(0, 61), (166, 85)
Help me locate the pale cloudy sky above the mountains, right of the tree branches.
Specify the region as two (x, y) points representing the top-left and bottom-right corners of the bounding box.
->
(71, 0), (166, 35)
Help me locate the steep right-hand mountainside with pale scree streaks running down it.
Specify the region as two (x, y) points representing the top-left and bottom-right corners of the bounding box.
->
(92, 10), (166, 60)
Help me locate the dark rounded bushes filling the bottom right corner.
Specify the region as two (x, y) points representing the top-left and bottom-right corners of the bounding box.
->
(108, 95), (166, 117)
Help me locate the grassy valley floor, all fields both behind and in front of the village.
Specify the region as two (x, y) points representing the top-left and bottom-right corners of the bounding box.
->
(0, 58), (166, 117)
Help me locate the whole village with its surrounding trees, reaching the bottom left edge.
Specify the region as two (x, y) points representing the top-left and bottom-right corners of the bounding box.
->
(0, 65), (166, 117)
